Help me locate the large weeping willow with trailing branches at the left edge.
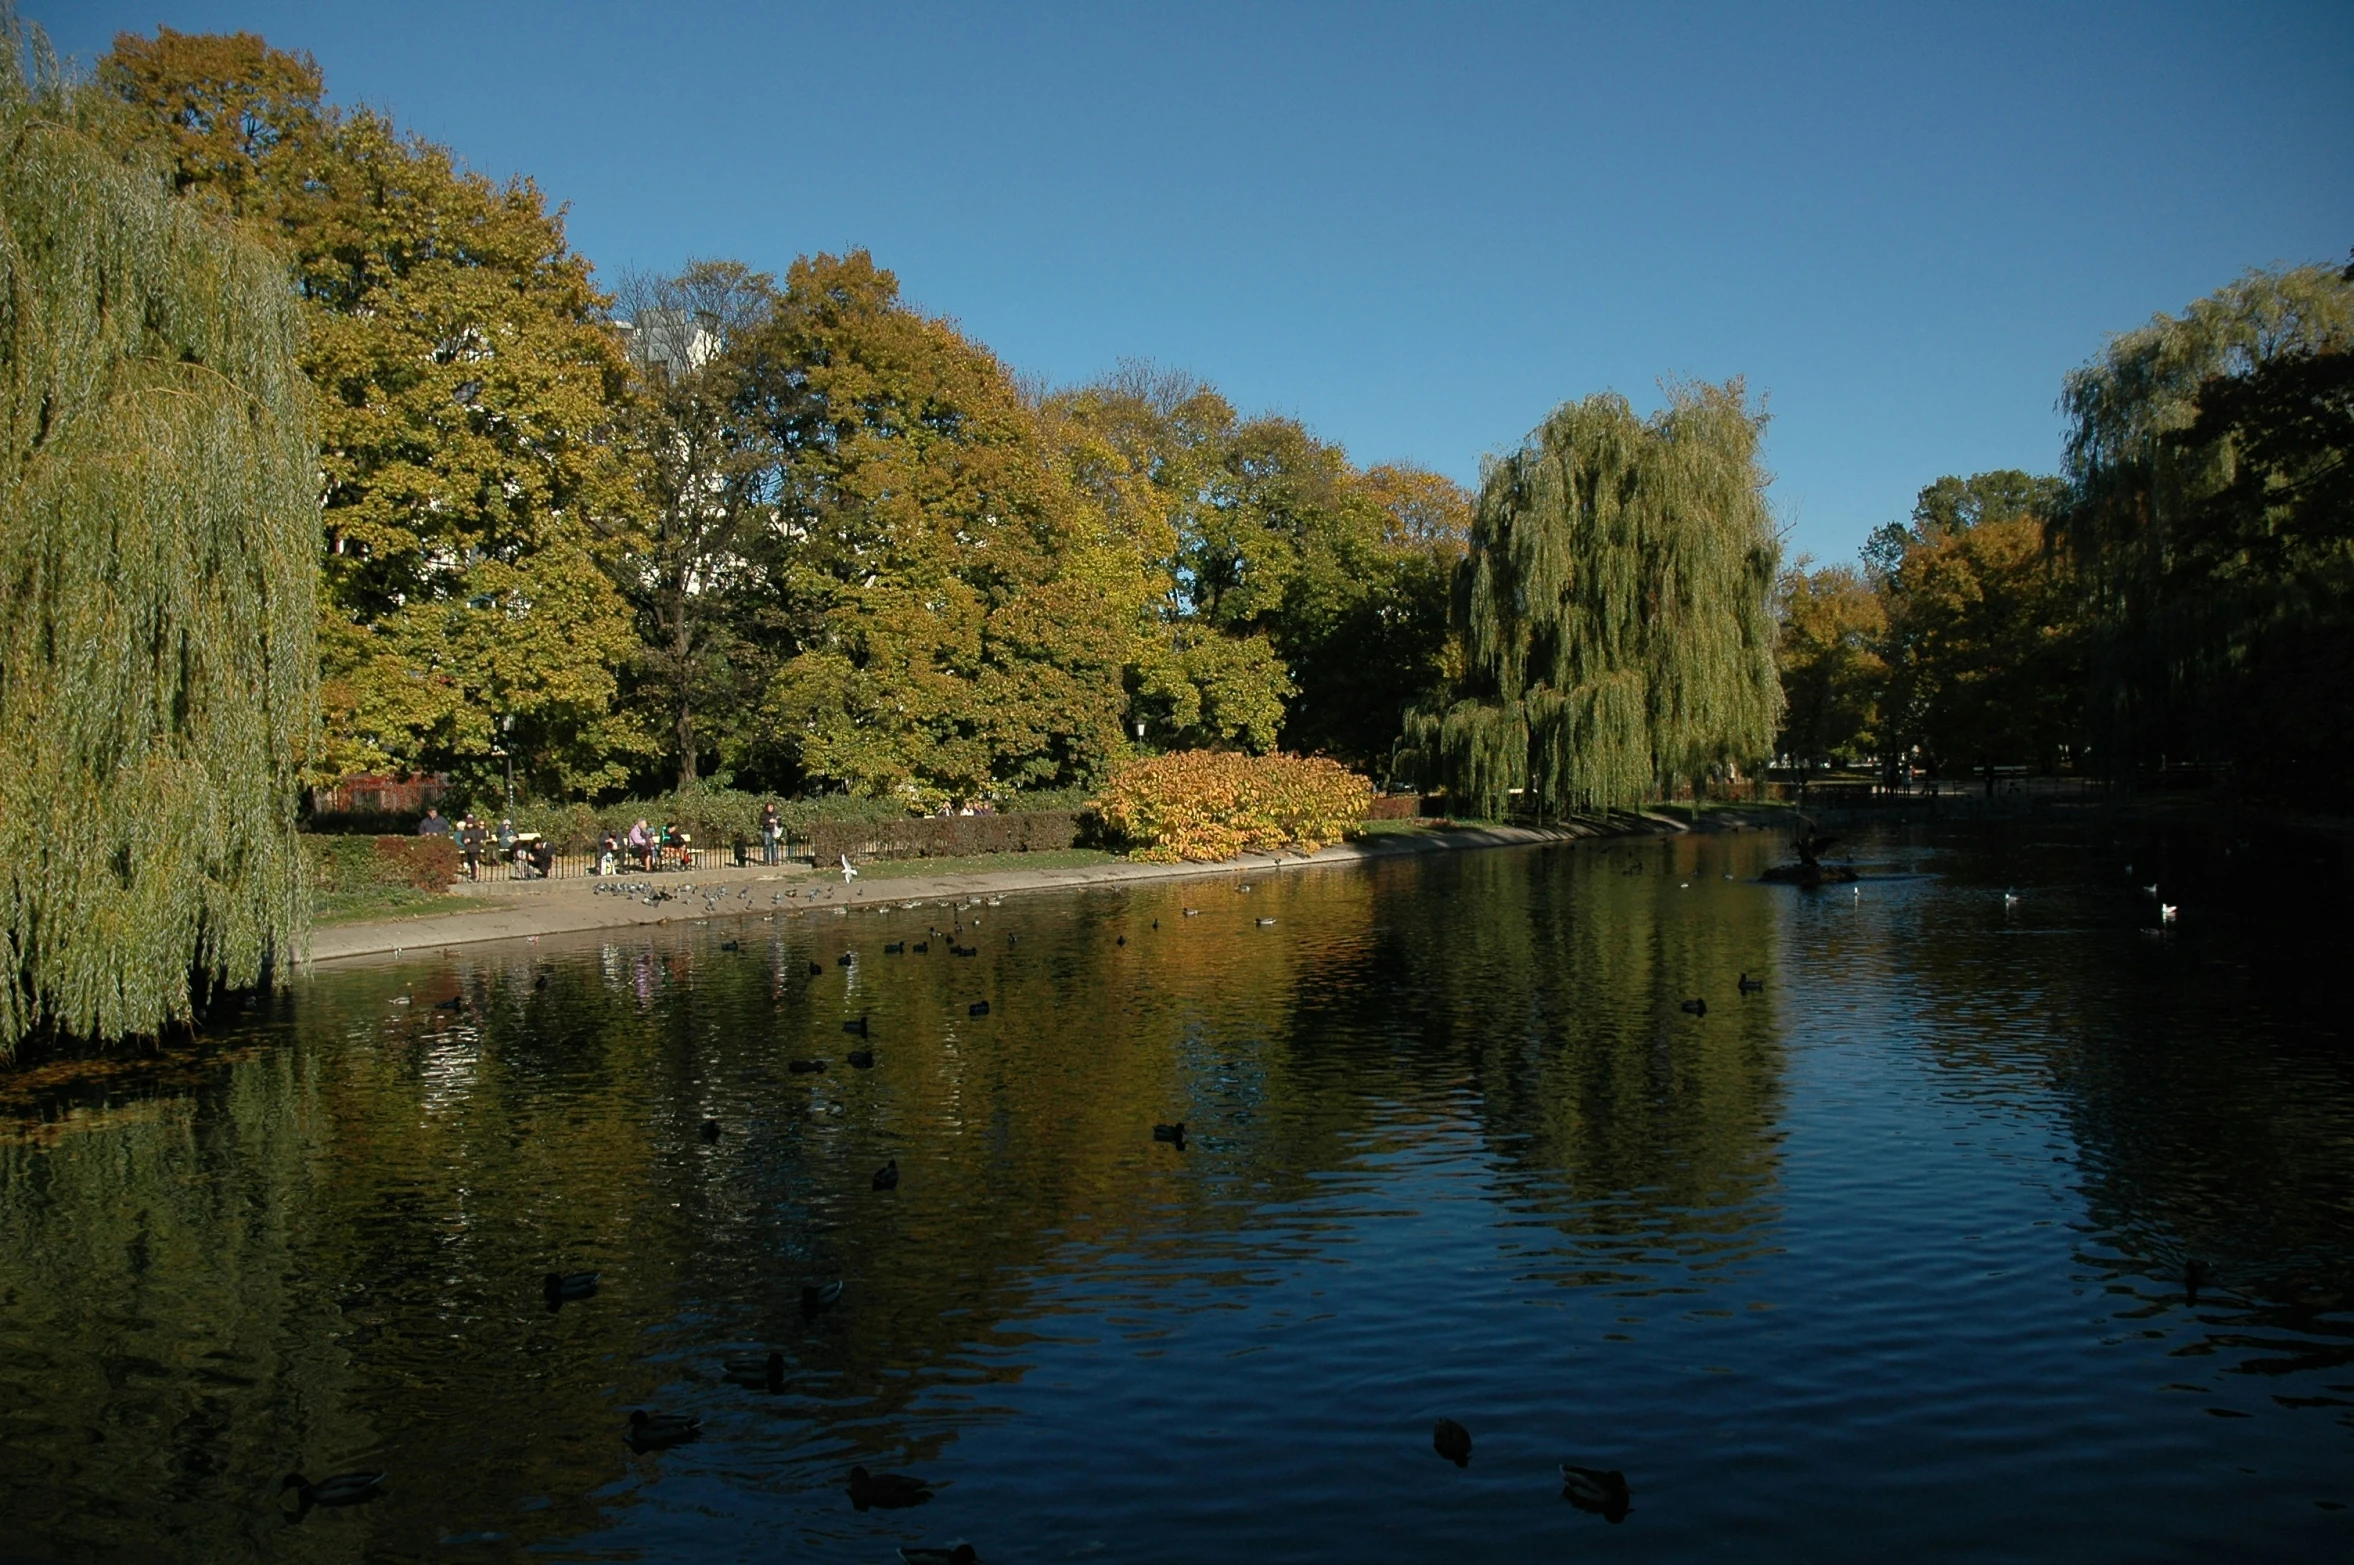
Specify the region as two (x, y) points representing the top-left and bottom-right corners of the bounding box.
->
(0, 9), (318, 1059)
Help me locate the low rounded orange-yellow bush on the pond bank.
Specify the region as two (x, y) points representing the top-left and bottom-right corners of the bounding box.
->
(1095, 751), (1372, 864)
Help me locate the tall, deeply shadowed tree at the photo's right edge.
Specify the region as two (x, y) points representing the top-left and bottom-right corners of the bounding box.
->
(2062, 266), (2354, 791)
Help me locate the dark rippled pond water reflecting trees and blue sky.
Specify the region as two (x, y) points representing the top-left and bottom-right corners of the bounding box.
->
(0, 824), (2354, 1563)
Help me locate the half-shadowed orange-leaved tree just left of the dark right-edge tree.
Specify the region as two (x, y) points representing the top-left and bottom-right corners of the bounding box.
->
(1867, 471), (2083, 788)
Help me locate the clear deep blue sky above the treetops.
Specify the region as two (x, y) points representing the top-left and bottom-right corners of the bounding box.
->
(36, 0), (2354, 558)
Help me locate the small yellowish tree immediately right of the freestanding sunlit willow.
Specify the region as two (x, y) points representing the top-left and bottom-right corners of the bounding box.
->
(1775, 560), (1888, 767)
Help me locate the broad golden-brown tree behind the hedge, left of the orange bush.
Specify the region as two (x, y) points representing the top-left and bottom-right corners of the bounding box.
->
(744, 252), (1151, 805)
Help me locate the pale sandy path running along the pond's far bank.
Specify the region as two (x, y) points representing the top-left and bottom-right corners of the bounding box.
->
(311, 810), (1784, 963)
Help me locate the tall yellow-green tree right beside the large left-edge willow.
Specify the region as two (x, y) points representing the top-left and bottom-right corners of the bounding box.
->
(99, 31), (645, 791)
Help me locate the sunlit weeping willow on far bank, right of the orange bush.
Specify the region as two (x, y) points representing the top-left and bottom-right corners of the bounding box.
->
(1401, 381), (1782, 814)
